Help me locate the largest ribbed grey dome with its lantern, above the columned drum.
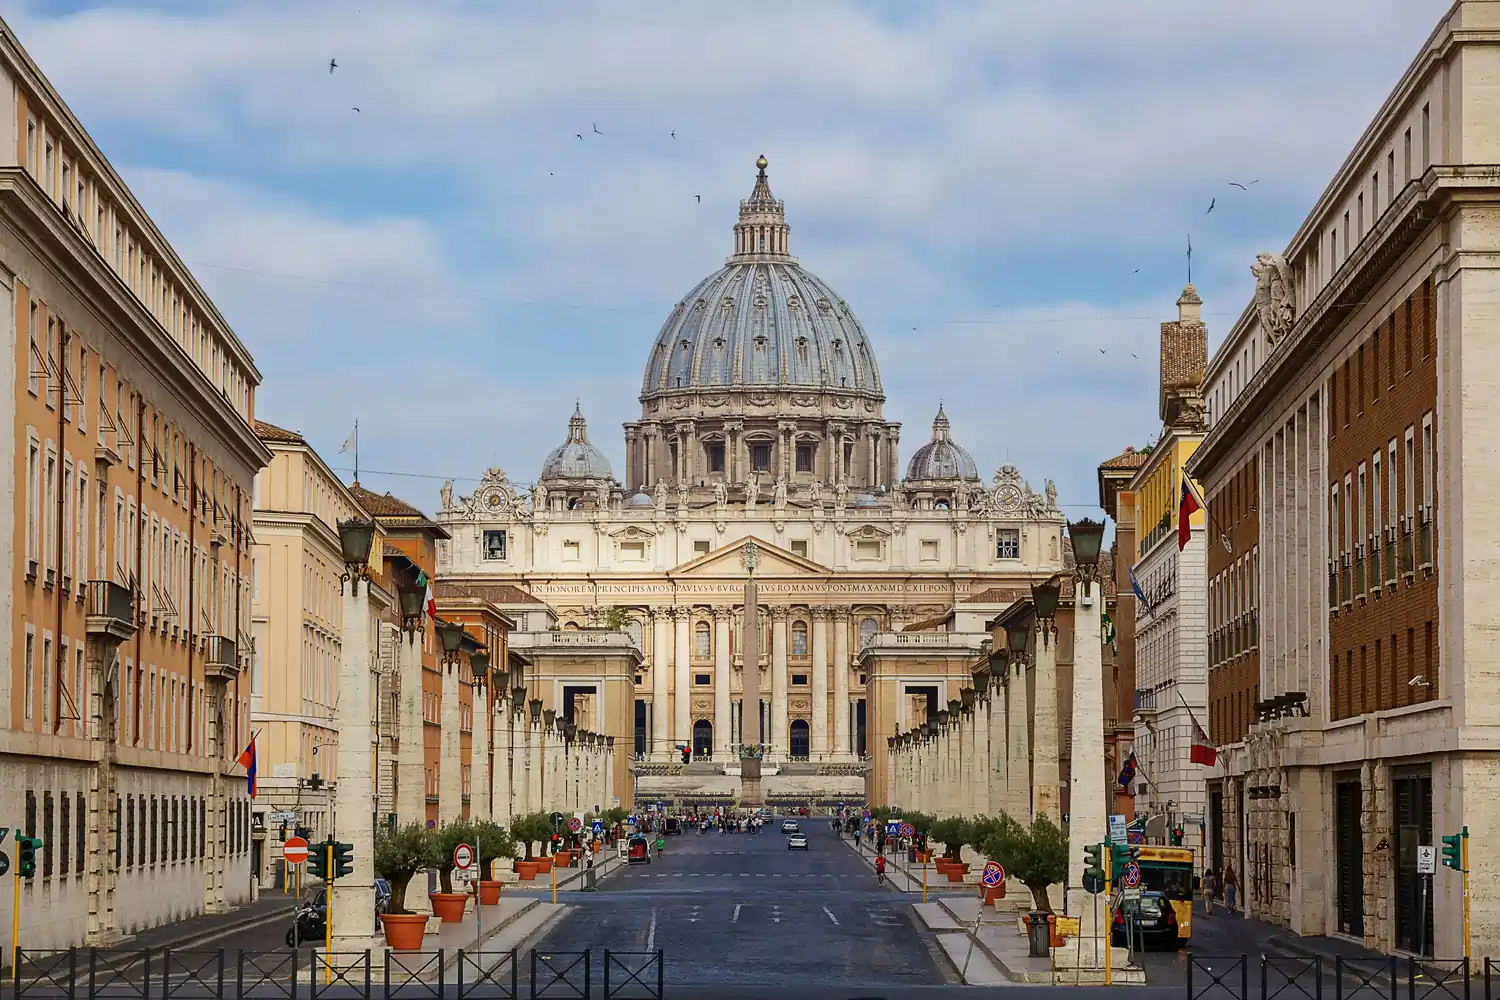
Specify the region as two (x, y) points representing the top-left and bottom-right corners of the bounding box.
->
(641, 156), (884, 402)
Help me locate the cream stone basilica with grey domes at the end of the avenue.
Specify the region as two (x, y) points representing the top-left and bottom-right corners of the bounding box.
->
(437, 157), (1065, 804)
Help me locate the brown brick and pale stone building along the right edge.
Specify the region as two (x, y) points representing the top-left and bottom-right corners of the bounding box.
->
(1190, 0), (1500, 957)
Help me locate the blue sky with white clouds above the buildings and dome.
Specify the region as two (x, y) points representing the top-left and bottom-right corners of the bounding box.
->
(5, 0), (1449, 516)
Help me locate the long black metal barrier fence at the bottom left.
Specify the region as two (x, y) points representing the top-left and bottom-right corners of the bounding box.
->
(0, 948), (665, 1000)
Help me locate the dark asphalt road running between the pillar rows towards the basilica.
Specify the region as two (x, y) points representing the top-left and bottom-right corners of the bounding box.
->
(537, 819), (945, 996)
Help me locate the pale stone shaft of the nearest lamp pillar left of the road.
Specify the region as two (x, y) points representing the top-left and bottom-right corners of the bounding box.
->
(330, 577), (375, 951)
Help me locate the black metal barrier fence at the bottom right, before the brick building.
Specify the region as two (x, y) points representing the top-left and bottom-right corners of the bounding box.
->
(1187, 954), (1482, 1000)
